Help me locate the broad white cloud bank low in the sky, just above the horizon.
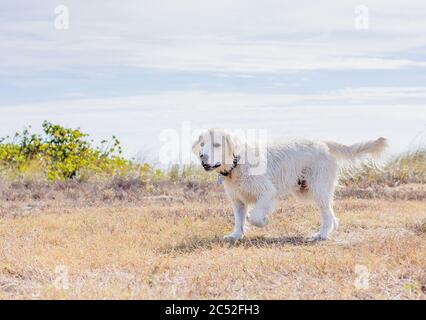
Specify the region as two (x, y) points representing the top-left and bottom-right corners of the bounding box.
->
(0, 87), (426, 158)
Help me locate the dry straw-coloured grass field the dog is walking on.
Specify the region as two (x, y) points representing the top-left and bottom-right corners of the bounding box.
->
(0, 183), (426, 299)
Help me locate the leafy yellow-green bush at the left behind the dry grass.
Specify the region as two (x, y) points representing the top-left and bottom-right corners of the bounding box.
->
(0, 121), (133, 180)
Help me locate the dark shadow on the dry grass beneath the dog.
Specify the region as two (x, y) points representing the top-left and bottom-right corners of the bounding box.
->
(161, 236), (317, 253)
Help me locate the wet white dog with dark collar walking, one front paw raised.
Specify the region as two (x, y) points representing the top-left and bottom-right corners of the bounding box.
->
(192, 129), (387, 240)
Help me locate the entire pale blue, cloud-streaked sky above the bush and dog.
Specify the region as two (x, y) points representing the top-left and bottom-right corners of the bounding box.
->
(0, 0), (426, 161)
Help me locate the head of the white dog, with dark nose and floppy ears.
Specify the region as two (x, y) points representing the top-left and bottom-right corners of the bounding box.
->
(192, 129), (237, 172)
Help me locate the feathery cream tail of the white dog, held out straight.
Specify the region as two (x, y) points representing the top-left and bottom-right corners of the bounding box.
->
(326, 138), (388, 161)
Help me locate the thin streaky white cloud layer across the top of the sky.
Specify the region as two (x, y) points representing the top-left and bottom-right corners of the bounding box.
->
(0, 0), (426, 73)
